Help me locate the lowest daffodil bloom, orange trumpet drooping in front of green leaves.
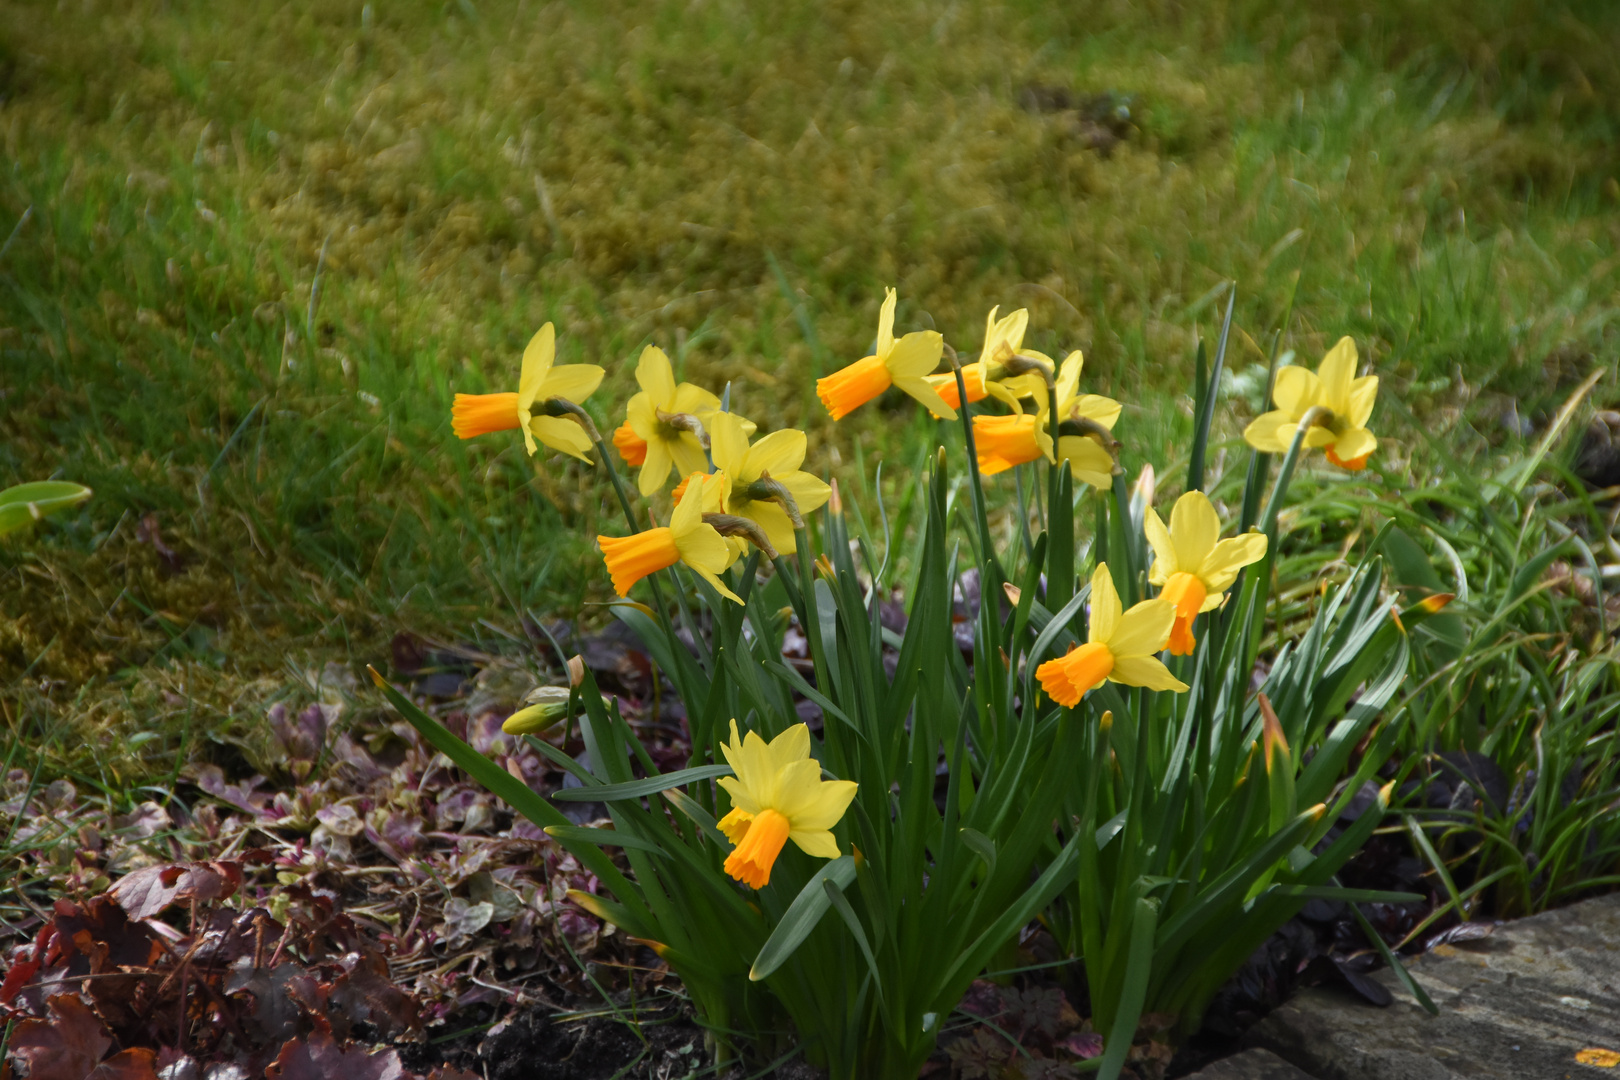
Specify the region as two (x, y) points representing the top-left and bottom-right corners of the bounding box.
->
(719, 721), (855, 889)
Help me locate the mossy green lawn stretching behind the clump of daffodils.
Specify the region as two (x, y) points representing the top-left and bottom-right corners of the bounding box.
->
(0, 0), (1620, 782)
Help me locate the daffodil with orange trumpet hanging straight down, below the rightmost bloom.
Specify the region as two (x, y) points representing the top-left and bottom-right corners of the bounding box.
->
(1142, 491), (1265, 656)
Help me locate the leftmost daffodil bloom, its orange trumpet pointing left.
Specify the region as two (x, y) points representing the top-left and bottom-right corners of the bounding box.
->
(450, 322), (603, 463)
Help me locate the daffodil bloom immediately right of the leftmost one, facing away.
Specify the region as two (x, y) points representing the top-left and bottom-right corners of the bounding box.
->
(614, 345), (719, 495)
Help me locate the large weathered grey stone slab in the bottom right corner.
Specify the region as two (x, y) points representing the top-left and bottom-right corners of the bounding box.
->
(1247, 894), (1620, 1080)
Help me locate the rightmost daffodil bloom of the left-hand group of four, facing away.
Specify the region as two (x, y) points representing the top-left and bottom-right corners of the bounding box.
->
(710, 413), (833, 555)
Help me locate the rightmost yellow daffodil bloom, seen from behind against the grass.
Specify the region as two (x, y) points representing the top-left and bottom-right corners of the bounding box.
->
(1243, 337), (1379, 471)
